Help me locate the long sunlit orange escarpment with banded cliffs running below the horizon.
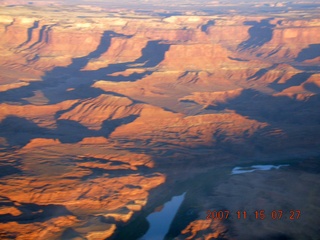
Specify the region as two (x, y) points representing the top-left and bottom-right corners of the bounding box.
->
(1, 7), (319, 77)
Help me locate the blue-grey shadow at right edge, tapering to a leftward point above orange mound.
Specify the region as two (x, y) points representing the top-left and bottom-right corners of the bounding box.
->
(207, 89), (320, 125)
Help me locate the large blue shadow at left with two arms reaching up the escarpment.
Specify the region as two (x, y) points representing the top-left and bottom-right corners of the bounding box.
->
(0, 31), (170, 104)
